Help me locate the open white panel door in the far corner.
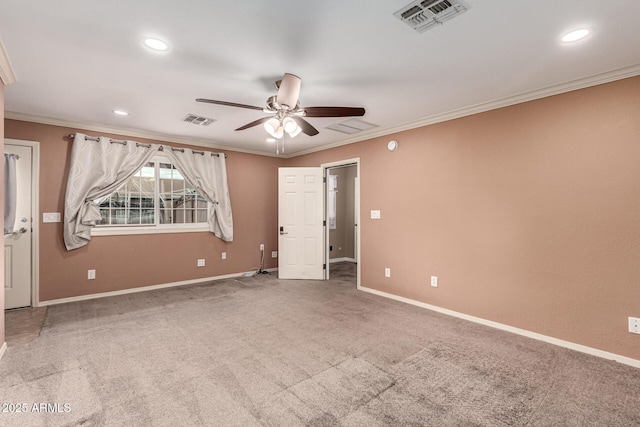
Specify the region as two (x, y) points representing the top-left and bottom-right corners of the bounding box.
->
(278, 168), (324, 280)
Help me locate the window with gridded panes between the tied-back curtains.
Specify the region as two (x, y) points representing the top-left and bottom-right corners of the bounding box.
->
(92, 156), (208, 235)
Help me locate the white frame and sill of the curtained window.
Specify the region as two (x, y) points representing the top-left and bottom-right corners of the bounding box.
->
(91, 155), (211, 237)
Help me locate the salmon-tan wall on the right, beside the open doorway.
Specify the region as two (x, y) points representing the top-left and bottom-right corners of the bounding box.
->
(287, 77), (640, 360)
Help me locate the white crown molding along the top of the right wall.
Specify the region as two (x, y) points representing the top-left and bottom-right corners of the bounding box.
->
(286, 64), (640, 158)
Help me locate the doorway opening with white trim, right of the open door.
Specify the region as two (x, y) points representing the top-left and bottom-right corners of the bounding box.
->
(322, 158), (360, 287)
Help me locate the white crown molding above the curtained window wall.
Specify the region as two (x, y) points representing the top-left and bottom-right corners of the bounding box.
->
(4, 111), (277, 157)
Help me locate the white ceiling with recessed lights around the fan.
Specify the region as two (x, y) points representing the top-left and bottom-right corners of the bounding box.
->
(0, 0), (640, 154)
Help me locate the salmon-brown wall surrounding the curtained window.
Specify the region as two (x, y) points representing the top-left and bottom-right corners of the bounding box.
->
(5, 120), (283, 301)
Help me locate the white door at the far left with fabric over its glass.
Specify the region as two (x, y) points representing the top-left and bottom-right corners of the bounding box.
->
(4, 144), (32, 309)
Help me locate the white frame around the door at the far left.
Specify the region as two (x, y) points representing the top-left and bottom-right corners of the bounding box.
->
(2, 138), (40, 310)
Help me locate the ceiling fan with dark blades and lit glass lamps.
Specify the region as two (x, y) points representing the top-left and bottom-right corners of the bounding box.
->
(196, 73), (365, 139)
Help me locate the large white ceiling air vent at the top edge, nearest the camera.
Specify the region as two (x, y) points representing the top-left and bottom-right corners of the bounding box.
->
(393, 0), (469, 33)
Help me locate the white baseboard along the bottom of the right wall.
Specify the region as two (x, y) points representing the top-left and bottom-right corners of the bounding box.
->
(358, 286), (640, 368)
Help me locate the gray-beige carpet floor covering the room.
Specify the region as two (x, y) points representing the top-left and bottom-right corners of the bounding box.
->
(0, 264), (640, 426)
